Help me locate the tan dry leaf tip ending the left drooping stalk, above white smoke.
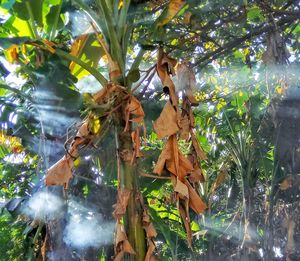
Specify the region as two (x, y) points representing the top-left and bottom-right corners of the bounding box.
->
(45, 156), (74, 189)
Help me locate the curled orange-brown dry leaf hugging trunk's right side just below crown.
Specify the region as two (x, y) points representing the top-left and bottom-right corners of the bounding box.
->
(124, 96), (145, 131)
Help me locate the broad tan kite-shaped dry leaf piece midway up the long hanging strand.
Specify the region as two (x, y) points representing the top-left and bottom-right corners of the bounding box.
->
(153, 101), (179, 139)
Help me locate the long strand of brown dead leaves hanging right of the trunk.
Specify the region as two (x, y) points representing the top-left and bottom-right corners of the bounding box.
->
(153, 50), (207, 247)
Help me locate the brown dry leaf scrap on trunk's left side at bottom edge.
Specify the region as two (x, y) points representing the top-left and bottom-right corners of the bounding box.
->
(115, 223), (135, 261)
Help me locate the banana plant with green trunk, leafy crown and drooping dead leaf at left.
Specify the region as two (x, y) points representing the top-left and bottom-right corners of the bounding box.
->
(0, 0), (202, 260)
